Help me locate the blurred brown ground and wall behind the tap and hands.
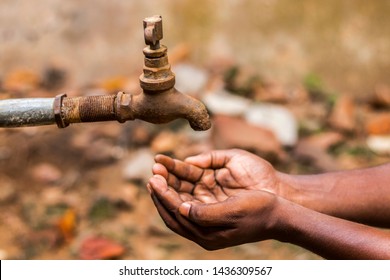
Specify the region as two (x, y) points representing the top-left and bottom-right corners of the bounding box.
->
(0, 0), (390, 259)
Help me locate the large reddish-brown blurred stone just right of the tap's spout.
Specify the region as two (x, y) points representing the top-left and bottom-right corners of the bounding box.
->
(211, 115), (284, 158)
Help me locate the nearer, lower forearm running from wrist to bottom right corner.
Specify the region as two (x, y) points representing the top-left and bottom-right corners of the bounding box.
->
(275, 200), (390, 259)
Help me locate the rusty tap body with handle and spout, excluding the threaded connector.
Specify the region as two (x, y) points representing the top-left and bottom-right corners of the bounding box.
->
(118, 16), (211, 130)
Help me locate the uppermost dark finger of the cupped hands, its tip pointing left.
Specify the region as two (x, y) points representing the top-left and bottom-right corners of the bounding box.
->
(155, 155), (203, 182)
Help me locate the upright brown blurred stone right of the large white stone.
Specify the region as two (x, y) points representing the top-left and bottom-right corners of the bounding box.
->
(329, 95), (356, 132)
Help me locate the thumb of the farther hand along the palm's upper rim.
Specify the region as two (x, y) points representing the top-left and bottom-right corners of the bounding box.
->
(184, 150), (238, 169)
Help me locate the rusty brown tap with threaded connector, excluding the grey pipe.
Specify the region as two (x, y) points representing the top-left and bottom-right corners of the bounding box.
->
(54, 16), (211, 130)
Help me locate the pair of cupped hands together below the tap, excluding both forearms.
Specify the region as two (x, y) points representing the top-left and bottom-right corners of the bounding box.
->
(148, 150), (284, 250)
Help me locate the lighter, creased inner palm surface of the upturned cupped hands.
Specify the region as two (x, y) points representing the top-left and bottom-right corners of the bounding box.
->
(156, 151), (277, 203)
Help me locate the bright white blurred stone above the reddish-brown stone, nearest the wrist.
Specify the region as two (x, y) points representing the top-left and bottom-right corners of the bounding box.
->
(245, 103), (298, 146)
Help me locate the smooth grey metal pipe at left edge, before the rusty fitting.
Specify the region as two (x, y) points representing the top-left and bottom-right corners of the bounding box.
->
(0, 98), (56, 127)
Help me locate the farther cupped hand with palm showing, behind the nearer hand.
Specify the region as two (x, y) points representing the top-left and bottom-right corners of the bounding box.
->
(153, 149), (281, 197)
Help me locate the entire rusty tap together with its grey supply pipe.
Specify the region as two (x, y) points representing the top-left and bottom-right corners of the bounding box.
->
(0, 16), (211, 130)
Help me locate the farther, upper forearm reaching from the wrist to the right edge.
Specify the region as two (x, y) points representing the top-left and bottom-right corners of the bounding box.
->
(279, 164), (390, 227)
